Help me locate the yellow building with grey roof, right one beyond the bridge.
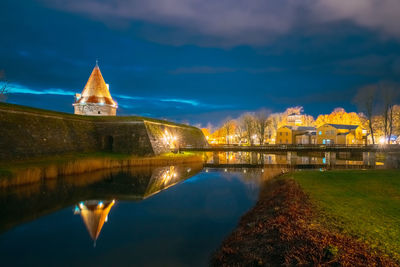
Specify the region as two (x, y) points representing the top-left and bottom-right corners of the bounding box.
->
(317, 124), (367, 145)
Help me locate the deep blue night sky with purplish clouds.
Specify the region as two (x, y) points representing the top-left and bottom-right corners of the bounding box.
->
(0, 0), (400, 126)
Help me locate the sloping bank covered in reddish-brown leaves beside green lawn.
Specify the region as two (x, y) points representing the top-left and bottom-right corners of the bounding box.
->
(211, 171), (398, 266)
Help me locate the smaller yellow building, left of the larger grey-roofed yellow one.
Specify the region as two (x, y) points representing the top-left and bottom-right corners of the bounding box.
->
(275, 125), (316, 145)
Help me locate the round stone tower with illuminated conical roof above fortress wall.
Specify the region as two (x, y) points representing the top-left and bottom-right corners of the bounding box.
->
(73, 62), (118, 116)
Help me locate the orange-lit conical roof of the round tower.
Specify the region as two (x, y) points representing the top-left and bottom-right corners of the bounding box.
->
(75, 61), (117, 106)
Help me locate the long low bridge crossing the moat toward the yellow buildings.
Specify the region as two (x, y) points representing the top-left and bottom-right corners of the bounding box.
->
(180, 144), (400, 153)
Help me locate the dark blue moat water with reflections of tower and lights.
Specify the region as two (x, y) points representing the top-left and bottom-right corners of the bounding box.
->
(0, 153), (399, 266)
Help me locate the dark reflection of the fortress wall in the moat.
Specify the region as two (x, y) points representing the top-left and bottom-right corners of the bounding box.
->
(0, 163), (203, 234)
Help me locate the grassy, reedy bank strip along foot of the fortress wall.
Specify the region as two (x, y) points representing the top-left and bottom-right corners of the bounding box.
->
(0, 152), (203, 188)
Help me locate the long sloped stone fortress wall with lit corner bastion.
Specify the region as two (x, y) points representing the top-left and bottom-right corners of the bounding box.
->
(0, 104), (208, 160)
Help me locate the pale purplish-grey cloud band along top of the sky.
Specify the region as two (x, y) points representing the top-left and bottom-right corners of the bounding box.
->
(42, 0), (400, 44)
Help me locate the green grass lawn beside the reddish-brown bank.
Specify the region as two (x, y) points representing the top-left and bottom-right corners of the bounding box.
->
(290, 170), (400, 261)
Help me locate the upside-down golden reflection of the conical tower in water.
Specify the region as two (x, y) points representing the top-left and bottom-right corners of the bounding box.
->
(75, 200), (115, 245)
